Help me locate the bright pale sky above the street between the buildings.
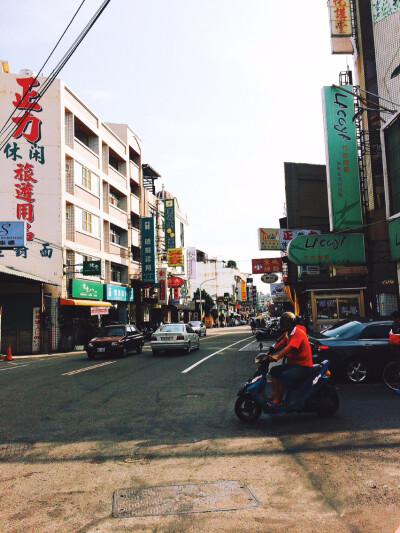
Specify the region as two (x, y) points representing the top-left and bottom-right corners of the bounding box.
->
(0, 0), (352, 292)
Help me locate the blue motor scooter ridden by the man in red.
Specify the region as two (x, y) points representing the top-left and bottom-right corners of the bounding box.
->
(235, 353), (339, 422)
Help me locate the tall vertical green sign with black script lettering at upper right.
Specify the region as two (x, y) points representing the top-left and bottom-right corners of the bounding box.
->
(322, 85), (362, 231)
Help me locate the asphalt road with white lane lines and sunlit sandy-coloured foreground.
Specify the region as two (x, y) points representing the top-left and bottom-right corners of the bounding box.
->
(0, 327), (400, 533)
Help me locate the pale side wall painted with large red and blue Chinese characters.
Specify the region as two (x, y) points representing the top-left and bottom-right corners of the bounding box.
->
(0, 73), (63, 286)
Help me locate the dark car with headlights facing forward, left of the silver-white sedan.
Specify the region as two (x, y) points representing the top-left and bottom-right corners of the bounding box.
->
(86, 324), (144, 359)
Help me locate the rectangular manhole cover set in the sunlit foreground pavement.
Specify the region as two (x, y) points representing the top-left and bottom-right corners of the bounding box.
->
(112, 481), (260, 518)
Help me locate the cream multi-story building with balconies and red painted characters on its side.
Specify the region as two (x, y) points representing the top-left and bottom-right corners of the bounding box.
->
(0, 68), (142, 353)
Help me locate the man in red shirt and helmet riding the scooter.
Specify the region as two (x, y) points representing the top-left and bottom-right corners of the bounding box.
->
(267, 312), (313, 407)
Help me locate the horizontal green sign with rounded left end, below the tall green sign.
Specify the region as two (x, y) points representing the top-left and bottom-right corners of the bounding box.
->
(288, 233), (365, 265)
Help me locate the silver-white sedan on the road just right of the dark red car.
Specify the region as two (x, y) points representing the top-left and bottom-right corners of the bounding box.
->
(150, 324), (200, 355)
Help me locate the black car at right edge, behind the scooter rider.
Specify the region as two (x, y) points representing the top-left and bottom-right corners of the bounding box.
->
(309, 320), (400, 384)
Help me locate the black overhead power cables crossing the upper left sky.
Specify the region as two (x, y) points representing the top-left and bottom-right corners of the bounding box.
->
(0, 0), (111, 151)
